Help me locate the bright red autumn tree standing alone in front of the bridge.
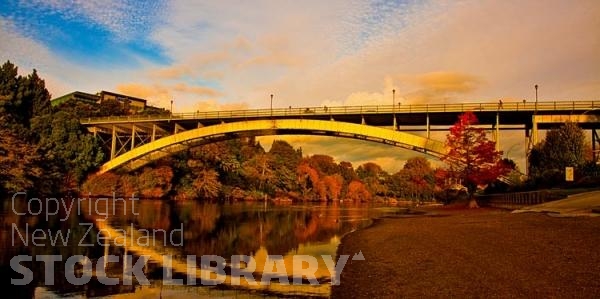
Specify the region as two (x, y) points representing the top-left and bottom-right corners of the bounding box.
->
(442, 112), (509, 208)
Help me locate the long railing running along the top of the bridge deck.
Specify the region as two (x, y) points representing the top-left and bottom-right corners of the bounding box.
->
(81, 101), (600, 124)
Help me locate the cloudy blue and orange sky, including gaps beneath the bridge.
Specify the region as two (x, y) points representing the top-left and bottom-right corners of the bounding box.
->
(0, 0), (600, 172)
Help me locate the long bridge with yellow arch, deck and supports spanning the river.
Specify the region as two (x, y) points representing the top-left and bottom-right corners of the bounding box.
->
(81, 101), (600, 173)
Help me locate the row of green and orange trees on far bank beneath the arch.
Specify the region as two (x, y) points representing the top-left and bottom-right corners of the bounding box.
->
(82, 138), (446, 201)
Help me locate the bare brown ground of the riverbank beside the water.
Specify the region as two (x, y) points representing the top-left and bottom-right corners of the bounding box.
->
(332, 208), (600, 298)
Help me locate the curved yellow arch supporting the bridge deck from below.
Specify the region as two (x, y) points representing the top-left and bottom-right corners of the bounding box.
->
(98, 119), (447, 174)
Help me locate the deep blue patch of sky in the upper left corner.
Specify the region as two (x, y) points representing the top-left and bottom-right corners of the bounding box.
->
(0, 0), (169, 68)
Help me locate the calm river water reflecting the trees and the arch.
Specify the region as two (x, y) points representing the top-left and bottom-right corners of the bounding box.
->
(0, 197), (404, 298)
